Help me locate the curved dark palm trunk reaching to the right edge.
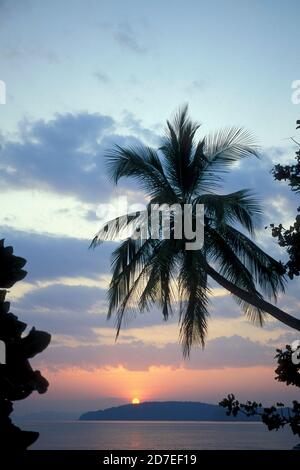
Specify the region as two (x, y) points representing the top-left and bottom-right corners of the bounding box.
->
(203, 260), (300, 331)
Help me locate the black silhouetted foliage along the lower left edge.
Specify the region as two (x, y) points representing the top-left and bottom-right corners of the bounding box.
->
(0, 240), (51, 452)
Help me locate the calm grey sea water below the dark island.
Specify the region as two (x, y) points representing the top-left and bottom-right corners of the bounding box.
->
(17, 421), (299, 450)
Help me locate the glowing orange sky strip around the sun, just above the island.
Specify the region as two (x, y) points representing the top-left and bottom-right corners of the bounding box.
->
(37, 366), (295, 404)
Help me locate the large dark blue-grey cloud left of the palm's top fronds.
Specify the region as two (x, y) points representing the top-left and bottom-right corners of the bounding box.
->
(0, 113), (140, 204)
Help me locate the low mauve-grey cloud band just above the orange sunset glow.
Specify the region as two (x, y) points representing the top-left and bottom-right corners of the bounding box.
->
(34, 335), (274, 370)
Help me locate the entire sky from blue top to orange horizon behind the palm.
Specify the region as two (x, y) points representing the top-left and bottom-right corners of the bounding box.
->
(0, 0), (300, 414)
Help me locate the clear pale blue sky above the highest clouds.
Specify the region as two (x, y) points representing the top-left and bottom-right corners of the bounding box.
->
(0, 0), (300, 141)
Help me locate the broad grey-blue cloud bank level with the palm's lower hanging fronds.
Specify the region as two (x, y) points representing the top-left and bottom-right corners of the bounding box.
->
(1, 228), (298, 342)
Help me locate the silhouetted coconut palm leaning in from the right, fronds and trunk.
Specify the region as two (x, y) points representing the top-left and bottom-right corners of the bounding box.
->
(91, 106), (300, 355)
